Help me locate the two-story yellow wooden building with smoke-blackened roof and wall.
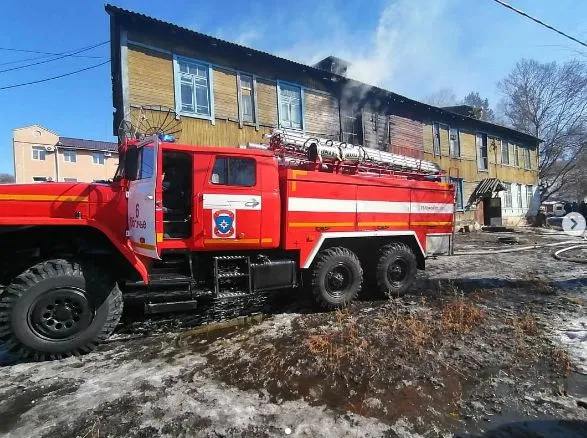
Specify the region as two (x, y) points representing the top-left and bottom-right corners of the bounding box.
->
(106, 5), (539, 229)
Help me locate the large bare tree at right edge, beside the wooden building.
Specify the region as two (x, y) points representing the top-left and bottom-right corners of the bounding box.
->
(498, 59), (587, 200)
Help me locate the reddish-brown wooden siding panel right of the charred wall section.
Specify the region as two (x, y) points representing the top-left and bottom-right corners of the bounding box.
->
(389, 115), (424, 159)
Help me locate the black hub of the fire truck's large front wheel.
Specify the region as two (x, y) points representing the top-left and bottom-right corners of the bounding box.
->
(29, 288), (94, 340)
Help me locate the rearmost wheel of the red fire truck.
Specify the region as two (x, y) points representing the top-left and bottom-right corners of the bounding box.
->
(375, 243), (418, 297)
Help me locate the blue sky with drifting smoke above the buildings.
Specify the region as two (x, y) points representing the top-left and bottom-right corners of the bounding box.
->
(0, 0), (587, 173)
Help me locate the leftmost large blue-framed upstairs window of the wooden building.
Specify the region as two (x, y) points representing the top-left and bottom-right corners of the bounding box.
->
(175, 58), (211, 118)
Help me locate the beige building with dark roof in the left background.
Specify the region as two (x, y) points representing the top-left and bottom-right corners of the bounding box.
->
(12, 125), (118, 183)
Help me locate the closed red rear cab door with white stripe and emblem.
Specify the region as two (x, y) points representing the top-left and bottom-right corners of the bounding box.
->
(198, 153), (263, 249)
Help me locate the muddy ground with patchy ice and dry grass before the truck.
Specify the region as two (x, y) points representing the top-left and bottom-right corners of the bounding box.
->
(0, 230), (587, 437)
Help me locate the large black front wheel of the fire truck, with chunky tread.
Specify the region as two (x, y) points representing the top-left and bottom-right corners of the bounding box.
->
(0, 259), (123, 360)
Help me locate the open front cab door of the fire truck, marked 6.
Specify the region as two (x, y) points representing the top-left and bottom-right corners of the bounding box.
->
(127, 138), (160, 259)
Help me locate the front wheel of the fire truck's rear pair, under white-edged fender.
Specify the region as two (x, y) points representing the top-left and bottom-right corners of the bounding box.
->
(312, 247), (363, 309)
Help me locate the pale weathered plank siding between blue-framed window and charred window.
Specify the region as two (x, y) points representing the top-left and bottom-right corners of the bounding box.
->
(304, 90), (340, 140)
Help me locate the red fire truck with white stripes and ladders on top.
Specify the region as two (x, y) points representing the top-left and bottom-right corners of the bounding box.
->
(0, 131), (454, 359)
